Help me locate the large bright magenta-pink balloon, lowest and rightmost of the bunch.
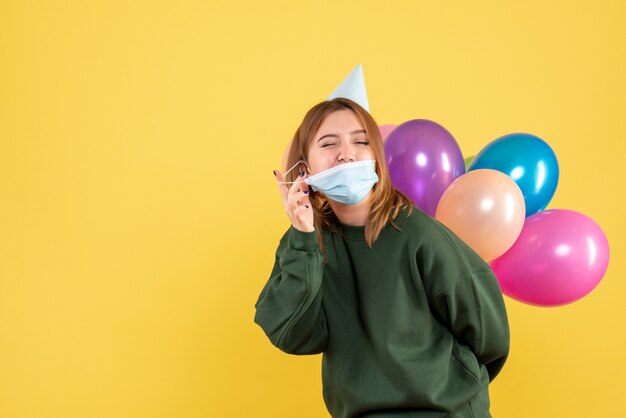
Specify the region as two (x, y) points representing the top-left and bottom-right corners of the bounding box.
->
(491, 209), (609, 306)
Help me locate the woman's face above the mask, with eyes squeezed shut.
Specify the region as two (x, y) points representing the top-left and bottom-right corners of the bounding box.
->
(307, 109), (374, 174)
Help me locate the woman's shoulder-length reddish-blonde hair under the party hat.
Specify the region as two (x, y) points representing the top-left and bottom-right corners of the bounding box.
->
(287, 97), (413, 251)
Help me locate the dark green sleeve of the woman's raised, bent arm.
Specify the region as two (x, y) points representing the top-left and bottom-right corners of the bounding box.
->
(254, 227), (328, 354)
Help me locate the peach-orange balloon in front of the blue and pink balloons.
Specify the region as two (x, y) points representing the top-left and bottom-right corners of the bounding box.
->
(435, 169), (526, 261)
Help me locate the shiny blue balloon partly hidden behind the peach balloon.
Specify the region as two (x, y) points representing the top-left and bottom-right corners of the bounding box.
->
(467, 133), (559, 216)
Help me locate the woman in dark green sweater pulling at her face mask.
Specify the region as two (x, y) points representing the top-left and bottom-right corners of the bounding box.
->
(255, 98), (509, 418)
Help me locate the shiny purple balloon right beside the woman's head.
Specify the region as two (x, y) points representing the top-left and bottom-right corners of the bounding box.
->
(385, 119), (465, 216)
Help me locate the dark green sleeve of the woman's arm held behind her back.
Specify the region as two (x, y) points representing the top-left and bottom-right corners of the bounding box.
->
(424, 222), (510, 381)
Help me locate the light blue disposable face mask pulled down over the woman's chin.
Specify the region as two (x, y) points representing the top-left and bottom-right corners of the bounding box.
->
(284, 160), (378, 205)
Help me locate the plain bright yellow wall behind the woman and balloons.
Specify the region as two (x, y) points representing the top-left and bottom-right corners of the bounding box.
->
(0, 0), (626, 418)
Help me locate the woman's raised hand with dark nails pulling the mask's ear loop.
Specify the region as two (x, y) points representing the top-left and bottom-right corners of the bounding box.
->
(274, 171), (315, 232)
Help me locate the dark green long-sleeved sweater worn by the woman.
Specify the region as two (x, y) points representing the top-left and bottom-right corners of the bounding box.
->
(255, 208), (509, 418)
